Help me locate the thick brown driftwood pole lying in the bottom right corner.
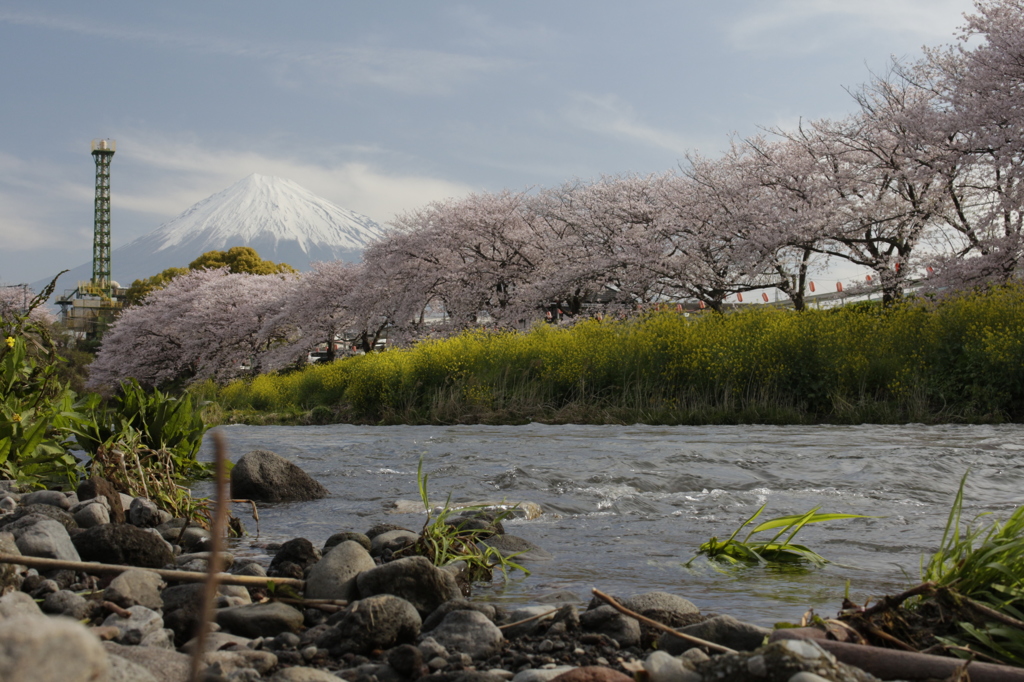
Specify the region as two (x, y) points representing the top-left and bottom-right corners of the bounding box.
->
(771, 628), (1024, 682)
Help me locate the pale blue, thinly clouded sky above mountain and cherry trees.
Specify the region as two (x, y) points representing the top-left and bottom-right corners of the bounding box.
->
(0, 0), (973, 285)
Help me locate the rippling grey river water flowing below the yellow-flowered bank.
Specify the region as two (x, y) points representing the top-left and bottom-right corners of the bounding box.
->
(199, 424), (1024, 625)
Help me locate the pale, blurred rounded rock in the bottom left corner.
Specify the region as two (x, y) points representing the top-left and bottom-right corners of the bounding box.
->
(0, 615), (111, 682)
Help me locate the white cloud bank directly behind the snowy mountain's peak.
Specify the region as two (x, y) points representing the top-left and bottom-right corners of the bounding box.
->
(117, 134), (473, 222)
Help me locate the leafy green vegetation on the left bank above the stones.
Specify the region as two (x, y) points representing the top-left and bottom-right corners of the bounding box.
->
(0, 280), (207, 491)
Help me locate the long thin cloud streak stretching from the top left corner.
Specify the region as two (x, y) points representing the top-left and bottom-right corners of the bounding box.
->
(0, 10), (512, 95)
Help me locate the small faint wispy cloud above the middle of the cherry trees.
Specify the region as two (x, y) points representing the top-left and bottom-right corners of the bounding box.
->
(563, 92), (697, 156)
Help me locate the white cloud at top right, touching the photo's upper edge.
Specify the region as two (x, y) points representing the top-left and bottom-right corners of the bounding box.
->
(727, 0), (973, 53)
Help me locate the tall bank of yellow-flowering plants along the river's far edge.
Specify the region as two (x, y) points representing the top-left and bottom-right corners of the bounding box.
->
(201, 287), (1024, 424)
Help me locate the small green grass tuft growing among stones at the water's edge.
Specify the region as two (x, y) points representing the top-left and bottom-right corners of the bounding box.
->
(399, 458), (529, 583)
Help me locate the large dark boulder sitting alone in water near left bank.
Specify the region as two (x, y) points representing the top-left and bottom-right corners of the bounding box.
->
(231, 450), (329, 502)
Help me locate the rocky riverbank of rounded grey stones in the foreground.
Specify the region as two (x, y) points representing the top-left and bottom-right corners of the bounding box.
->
(0, 454), (1024, 682)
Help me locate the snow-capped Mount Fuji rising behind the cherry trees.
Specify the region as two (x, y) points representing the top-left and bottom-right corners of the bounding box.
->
(32, 174), (384, 292)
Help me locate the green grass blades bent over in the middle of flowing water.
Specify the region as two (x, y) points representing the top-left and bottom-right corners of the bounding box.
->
(685, 505), (868, 566)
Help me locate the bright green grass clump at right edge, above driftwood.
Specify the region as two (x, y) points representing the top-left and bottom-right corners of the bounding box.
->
(922, 473), (1024, 666)
